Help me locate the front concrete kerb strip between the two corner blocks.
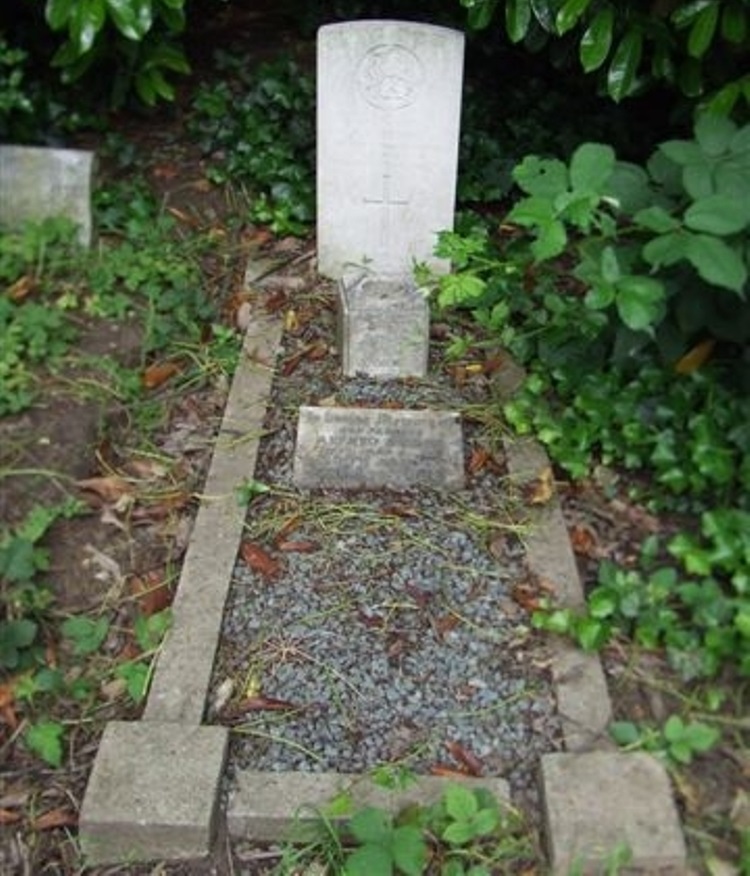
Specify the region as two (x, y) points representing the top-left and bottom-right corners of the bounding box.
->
(227, 770), (510, 842)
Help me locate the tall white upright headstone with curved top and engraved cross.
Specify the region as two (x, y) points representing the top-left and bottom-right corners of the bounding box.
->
(317, 21), (464, 279)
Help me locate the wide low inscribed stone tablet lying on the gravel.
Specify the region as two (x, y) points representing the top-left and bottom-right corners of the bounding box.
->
(294, 407), (464, 489)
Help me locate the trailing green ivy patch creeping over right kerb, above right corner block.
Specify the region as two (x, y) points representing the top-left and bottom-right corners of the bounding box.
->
(534, 509), (750, 680)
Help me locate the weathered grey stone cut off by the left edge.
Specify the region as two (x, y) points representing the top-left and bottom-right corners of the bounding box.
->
(0, 146), (94, 246)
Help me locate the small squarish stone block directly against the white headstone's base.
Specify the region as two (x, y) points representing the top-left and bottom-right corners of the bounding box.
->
(339, 277), (430, 379)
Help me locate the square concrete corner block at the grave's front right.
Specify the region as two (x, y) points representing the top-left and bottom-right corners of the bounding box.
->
(541, 751), (687, 876)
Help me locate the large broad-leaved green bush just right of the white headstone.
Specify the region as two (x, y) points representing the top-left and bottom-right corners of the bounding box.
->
(508, 115), (750, 358)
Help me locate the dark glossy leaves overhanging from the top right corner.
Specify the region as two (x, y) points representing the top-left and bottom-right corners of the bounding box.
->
(460, 0), (750, 114)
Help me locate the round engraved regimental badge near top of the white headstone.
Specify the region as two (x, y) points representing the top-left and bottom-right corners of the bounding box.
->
(357, 45), (424, 110)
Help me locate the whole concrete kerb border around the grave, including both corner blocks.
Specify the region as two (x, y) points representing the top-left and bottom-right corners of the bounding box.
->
(79, 261), (685, 874)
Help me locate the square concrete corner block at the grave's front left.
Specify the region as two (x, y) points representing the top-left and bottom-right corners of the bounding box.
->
(80, 721), (228, 865)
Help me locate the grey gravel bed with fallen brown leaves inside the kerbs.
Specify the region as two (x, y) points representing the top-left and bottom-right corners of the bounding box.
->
(209, 290), (560, 794)
